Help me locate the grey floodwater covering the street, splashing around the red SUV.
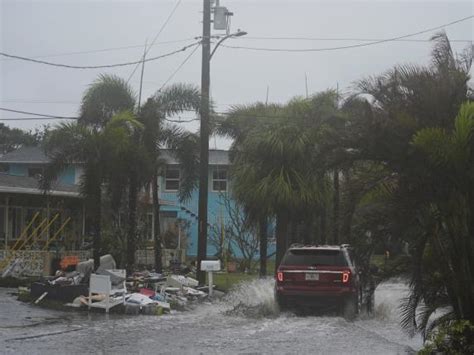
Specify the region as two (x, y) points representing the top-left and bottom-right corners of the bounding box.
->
(0, 280), (422, 354)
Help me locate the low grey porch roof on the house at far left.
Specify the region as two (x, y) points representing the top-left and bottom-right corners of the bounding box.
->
(0, 174), (80, 198)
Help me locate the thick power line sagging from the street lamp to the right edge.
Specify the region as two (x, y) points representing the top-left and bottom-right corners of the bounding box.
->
(222, 15), (474, 52)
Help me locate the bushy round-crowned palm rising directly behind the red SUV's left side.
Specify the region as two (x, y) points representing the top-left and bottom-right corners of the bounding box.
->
(232, 122), (324, 272)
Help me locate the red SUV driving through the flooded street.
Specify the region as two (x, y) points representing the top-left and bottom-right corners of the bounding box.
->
(275, 245), (361, 319)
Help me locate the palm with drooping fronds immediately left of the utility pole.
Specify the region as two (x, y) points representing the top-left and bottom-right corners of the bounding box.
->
(139, 84), (200, 272)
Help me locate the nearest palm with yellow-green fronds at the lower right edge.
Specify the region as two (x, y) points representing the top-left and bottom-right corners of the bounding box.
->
(404, 103), (474, 331)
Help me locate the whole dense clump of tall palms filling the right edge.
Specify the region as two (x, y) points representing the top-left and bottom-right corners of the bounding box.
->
(344, 33), (474, 334)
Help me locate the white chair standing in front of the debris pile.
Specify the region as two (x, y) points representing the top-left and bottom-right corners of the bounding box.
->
(88, 270), (127, 313)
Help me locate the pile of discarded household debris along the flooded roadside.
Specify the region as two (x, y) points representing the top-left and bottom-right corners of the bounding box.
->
(24, 255), (213, 315)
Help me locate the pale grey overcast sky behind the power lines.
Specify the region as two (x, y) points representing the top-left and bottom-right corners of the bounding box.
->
(0, 0), (474, 148)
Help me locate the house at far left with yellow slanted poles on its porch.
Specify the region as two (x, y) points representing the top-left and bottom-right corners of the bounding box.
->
(0, 147), (86, 253)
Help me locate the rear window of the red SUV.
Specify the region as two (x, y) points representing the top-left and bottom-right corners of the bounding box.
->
(281, 249), (348, 266)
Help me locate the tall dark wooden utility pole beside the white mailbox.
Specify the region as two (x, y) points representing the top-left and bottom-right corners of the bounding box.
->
(196, 0), (211, 285)
